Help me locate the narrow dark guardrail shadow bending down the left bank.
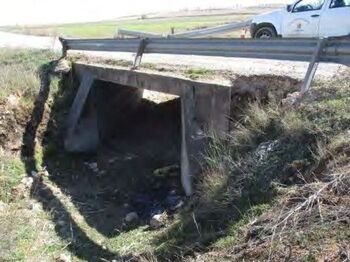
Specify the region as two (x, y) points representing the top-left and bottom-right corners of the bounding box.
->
(21, 64), (118, 261)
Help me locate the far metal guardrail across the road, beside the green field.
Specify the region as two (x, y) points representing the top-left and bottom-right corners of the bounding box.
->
(118, 20), (252, 38)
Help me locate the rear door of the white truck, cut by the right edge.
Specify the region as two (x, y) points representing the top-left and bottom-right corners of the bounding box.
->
(320, 0), (350, 37)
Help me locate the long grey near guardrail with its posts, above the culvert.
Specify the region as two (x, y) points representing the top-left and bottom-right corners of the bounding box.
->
(60, 36), (350, 92)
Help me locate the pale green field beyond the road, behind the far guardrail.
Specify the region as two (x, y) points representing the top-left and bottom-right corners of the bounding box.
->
(0, 14), (251, 38)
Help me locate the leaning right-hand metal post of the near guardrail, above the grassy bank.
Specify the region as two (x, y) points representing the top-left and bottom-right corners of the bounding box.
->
(301, 38), (327, 94)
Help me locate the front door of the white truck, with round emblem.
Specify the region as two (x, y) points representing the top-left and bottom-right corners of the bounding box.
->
(282, 0), (328, 37)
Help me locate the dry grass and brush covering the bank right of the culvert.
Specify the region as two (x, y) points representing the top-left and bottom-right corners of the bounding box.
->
(183, 71), (350, 261)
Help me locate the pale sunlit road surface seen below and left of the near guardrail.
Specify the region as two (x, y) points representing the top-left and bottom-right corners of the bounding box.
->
(0, 32), (346, 80)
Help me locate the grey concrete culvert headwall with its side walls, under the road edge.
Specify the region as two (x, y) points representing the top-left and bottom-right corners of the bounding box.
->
(65, 64), (231, 195)
